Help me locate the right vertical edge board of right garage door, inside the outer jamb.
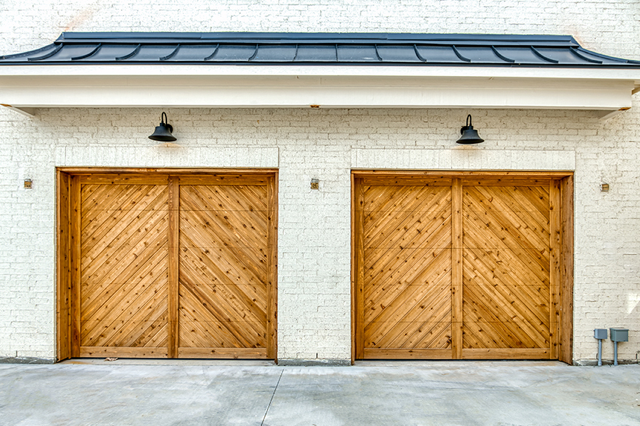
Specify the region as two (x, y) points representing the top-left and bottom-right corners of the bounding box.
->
(549, 180), (562, 359)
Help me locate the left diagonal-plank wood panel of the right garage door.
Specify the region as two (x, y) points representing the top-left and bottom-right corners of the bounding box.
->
(362, 185), (451, 358)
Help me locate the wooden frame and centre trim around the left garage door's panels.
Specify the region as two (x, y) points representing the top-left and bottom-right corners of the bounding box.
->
(56, 168), (278, 360)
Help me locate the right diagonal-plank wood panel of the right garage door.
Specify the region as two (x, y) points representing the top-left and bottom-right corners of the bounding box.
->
(463, 185), (550, 358)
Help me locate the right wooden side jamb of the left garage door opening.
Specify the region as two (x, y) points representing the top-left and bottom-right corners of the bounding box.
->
(267, 173), (278, 362)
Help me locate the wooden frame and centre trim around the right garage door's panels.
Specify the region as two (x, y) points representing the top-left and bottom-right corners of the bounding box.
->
(351, 171), (573, 363)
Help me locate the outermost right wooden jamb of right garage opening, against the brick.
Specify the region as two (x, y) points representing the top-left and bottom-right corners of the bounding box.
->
(559, 176), (574, 364)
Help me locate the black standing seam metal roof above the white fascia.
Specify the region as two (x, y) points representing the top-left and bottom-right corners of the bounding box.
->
(0, 33), (640, 68)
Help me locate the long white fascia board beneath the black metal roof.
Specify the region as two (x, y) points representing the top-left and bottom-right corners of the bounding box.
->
(0, 65), (640, 111)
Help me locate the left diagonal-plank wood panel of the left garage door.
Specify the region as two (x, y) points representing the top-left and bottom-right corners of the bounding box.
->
(80, 184), (168, 356)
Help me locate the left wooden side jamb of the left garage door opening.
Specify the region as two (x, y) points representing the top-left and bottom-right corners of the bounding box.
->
(56, 170), (71, 361)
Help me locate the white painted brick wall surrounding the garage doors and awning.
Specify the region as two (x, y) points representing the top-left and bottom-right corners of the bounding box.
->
(0, 0), (640, 359)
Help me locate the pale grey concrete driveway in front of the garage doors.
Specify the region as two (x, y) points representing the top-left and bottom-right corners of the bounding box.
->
(0, 360), (640, 426)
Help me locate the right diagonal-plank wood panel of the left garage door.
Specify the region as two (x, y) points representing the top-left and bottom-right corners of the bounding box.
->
(179, 185), (269, 358)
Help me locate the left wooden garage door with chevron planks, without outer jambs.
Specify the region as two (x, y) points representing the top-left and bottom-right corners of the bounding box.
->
(59, 173), (276, 358)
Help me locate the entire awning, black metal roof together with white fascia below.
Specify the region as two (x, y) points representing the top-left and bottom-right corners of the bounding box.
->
(0, 33), (640, 115)
